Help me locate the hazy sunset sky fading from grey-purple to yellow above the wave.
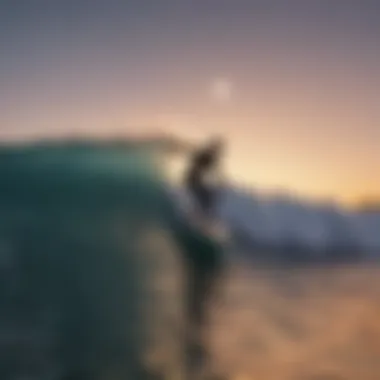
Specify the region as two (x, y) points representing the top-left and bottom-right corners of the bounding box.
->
(0, 0), (380, 202)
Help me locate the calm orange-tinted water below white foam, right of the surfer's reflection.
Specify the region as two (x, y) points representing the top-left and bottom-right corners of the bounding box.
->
(206, 263), (380, 380)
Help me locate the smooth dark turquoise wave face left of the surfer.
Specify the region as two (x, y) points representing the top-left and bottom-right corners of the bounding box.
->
(0, 142), (186, 380)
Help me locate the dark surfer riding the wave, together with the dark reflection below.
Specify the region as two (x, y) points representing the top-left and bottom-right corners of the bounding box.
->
(180, 138), (224, 369)
